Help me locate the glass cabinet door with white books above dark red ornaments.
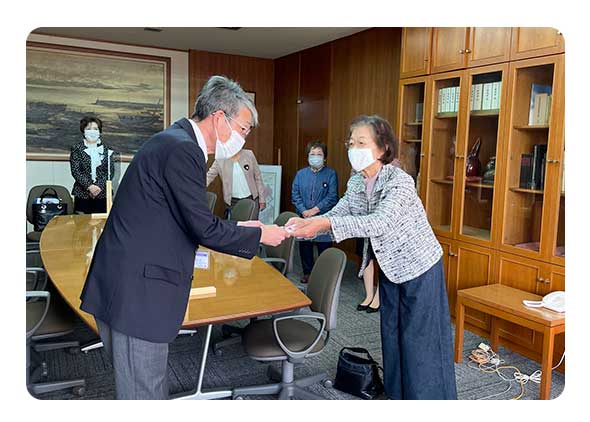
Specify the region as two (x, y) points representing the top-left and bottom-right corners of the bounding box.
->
(457, 65), (508, 241)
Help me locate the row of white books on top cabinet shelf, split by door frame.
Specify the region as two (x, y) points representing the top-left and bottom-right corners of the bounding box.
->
(437, 81), (502, 113)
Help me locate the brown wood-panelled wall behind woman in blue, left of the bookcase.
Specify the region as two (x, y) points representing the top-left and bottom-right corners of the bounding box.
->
(274, 28), (401, 256)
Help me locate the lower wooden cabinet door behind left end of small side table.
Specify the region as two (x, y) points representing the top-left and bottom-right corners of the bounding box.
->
(452, 242), (496, 331)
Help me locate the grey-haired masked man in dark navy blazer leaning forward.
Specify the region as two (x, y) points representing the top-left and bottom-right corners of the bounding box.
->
(80, 76), (288, 399)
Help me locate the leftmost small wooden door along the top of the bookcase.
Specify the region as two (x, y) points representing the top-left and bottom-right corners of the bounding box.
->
(400, 28), (432, 78)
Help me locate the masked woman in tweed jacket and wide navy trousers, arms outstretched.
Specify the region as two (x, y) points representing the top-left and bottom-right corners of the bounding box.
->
(286, 116), (457, 399)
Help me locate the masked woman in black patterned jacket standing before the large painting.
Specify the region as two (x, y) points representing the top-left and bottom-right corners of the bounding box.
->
(70, 116), (115, 214)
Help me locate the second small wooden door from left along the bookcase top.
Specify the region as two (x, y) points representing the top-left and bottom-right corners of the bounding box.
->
(430, 28), (469, 73)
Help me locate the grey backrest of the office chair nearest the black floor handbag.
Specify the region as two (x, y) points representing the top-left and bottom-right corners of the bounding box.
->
(306, 248), (346, 331)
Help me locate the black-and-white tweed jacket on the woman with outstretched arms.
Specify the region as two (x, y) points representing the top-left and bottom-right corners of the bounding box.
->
(319, 164), (442, 283)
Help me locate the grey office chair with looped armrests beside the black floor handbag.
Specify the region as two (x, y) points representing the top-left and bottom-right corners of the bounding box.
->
(233, 248), (346, 399)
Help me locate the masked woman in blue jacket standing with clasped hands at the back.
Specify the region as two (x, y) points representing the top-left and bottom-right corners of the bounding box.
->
(291, 141), (338, 284)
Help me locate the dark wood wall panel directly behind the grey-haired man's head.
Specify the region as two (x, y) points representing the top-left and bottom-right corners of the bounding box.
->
(187, 50), (275, 215)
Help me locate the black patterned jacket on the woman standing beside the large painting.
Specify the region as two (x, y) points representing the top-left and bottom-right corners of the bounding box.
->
(70, 140), (115, 199)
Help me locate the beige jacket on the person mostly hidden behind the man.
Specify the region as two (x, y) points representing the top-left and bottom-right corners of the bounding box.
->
(207, 149), (265, 205)
